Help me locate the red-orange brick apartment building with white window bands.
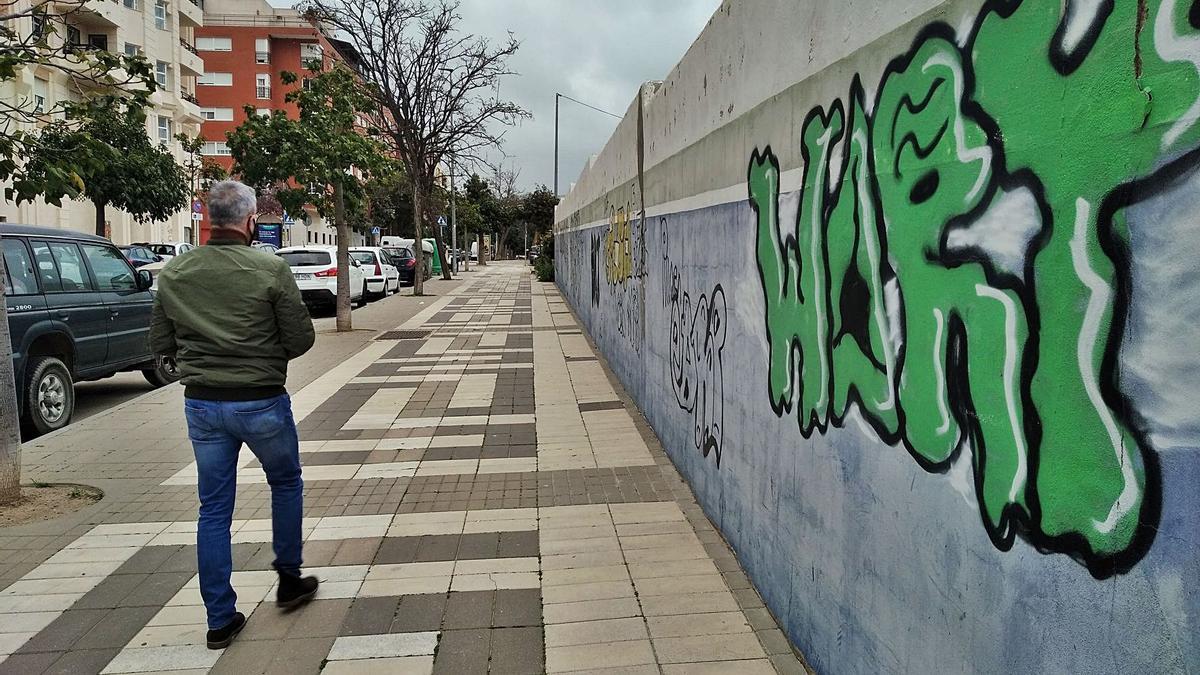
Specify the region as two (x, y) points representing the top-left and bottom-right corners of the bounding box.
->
(196, 0), (361, 246)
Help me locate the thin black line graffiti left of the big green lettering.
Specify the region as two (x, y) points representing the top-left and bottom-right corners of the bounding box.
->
(659, 219), (726, 466)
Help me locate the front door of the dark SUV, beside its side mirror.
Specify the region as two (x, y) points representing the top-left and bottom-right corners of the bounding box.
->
(83, 244), (154, 366)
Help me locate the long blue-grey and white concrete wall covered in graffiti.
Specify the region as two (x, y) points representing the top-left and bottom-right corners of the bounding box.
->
(556, 0), (1200, 673)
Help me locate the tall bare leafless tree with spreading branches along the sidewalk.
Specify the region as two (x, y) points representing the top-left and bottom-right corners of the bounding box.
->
(301, 0), (530, 294)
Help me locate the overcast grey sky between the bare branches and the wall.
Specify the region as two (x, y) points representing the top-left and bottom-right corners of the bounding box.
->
(276, 0), (720, 195)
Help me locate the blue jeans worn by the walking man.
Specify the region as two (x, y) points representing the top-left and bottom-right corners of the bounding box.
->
(184, 394), (304, 629)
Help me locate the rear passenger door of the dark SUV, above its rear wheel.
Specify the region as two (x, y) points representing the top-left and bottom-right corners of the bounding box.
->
(29, 239), (108, 376)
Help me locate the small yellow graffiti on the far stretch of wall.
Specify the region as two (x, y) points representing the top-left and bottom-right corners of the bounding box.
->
(601, 195), (646, 353)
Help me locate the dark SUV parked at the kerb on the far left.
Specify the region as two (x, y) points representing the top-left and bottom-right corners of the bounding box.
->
(0, 225), (179, 434)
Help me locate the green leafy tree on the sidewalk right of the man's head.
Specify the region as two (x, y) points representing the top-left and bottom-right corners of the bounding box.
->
(228, 66), (385, 330)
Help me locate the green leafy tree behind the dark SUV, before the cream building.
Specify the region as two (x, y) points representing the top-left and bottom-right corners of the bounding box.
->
(12, 106), (192, 237)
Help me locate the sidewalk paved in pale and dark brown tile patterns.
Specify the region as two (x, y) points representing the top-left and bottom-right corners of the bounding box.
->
(0, 264), (803, 674)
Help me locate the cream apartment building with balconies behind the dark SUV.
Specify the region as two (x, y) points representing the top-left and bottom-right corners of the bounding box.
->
(0, 0), (204, 244)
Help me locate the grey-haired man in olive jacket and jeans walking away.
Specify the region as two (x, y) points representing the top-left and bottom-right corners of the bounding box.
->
(150, 180), (318, 650)
